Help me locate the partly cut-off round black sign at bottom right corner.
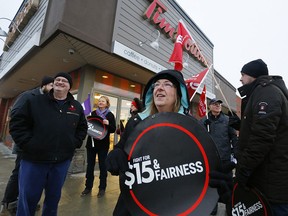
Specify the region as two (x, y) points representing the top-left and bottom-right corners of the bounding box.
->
(232, 184), (273, 216)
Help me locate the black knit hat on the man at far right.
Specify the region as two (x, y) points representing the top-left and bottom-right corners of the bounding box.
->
(241, 59), (268, 78)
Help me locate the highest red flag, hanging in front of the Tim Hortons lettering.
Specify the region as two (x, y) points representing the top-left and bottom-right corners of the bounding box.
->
(169, 20), (193, 71)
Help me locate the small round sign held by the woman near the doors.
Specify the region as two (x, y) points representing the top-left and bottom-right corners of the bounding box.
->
(87, 116), (107, 140)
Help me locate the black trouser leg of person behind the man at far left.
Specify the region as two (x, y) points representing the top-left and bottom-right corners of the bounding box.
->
(2, 154), (21, 203)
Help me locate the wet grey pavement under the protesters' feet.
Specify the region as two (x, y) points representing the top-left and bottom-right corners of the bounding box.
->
(0, 142), (225, 216)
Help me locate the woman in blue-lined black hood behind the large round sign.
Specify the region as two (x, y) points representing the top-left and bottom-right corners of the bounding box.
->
(106, 70), (231, 216)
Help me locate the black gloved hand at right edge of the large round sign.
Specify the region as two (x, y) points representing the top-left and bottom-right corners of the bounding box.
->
(209, 162), (235, 204)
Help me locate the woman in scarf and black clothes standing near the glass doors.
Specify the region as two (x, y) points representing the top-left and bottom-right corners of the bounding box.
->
(81, 96), (116, 198)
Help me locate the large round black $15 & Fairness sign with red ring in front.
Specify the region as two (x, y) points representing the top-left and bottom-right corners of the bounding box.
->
(120, 113), (220, 216)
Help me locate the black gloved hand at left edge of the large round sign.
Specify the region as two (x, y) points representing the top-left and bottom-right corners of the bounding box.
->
(105, 148), (128, 175)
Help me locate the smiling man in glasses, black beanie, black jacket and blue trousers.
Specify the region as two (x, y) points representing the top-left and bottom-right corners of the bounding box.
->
(10, 72), (87, 215)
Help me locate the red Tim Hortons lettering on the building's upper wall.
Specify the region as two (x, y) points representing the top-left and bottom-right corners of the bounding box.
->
(143, 0), (207, 66)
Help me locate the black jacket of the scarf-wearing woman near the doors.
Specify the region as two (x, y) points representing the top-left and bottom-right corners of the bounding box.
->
(86, 110), (116, 150)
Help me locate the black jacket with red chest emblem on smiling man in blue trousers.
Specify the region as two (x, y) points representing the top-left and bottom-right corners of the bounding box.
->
(10, 89), (87, 163)
